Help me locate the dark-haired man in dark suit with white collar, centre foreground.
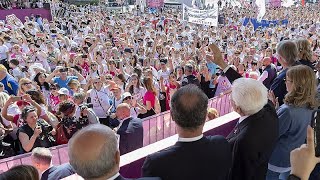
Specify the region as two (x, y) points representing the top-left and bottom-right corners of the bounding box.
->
(142, 85), (231, 180)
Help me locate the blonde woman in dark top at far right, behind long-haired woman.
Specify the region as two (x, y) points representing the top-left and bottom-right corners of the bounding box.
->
(295, 39), (314, 69)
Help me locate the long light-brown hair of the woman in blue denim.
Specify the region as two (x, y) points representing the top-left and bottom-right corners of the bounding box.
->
(284, 65), (318, 109)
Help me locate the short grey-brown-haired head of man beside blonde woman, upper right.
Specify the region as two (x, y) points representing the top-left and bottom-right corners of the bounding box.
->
(277, 40), (298, 66)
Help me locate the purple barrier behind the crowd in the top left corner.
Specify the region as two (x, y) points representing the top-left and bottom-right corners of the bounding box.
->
(0, 8), (52, 22)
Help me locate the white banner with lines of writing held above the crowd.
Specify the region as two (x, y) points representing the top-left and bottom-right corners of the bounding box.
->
(183, 5), (218, 26)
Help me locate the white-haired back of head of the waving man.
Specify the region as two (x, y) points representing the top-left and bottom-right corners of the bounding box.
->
(231, 78), (268, 116)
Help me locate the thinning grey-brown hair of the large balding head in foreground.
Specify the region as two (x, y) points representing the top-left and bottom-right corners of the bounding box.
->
(68, 124), (118, 179)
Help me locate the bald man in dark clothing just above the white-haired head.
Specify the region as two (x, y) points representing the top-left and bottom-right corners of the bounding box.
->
(258, 57), (277, 89)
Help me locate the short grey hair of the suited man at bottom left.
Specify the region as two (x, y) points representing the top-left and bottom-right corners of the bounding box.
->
(31, 147), (52, 165)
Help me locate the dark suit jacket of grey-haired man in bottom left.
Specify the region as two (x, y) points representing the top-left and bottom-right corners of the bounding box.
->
(41, 163), (75, 180)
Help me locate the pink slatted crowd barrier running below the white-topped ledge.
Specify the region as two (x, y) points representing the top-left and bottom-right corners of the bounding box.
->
(0, 94), (232, 173)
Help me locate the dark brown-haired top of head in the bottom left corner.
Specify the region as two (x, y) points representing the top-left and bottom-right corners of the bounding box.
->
(0, 165), (39, 180)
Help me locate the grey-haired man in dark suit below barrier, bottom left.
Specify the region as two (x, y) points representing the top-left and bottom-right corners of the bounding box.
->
(31, 147), (75, 180)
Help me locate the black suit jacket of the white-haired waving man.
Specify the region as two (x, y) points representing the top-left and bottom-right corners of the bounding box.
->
(227, 104), (279, 180)
